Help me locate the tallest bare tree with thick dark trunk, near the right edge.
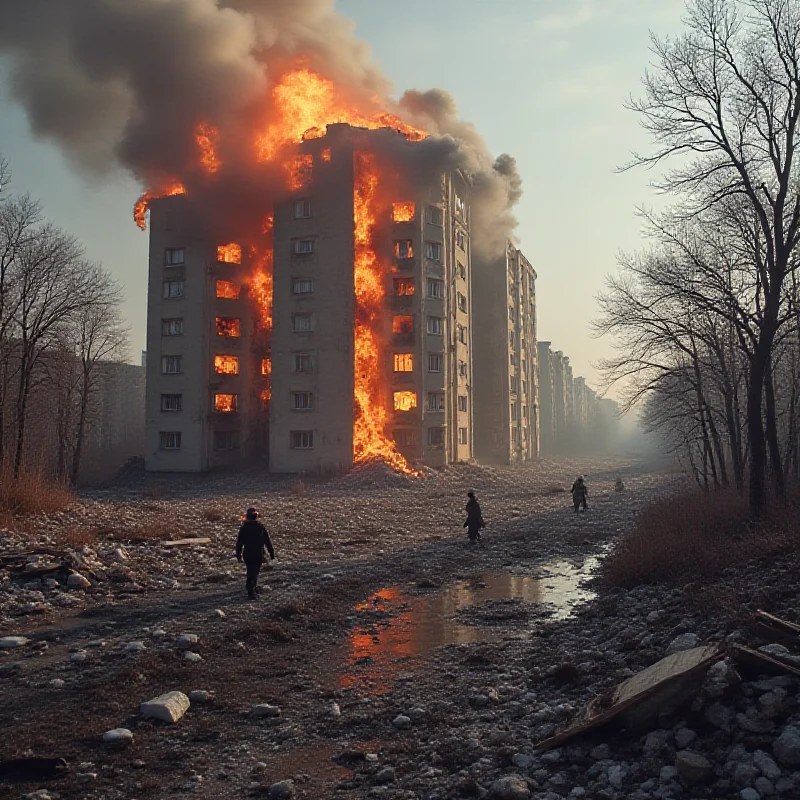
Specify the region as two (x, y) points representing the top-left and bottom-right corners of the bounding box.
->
(630, 0), (800, 513)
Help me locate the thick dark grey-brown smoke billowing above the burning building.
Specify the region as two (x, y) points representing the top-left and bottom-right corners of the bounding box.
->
(0, 0), (521, 257)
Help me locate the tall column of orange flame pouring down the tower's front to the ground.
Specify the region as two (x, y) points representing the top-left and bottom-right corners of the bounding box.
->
(353, 151), (413, 473)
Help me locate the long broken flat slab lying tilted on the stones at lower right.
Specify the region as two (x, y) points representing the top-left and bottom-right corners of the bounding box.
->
(536, 645), (724, 751)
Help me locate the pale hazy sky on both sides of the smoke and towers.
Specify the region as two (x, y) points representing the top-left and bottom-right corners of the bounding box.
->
(0, 0), (684, 394)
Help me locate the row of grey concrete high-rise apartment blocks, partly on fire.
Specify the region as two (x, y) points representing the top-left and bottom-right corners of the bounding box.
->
(146, 124), (608, 473)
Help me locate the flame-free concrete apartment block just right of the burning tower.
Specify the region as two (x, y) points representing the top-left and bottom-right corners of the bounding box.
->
(473, 242), (539, 464)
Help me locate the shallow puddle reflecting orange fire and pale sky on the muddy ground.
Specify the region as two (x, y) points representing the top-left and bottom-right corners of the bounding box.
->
(337, 558), (598, 693)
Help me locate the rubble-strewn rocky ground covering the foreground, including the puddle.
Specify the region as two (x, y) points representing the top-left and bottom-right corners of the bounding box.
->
(0, 459), (800, 800)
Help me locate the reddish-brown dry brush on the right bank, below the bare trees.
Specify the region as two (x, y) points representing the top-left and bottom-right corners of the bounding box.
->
(600, 484), (800, 588)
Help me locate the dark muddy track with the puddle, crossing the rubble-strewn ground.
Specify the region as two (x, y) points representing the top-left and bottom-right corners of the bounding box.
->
(0, 460), (661, 798)
